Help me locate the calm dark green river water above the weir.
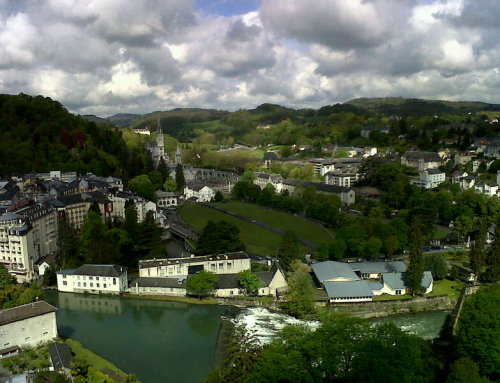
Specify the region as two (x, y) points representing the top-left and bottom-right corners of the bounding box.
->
(45, 291), (225, 383)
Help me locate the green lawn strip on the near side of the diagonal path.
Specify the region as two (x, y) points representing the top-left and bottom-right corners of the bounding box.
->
(181, 204), (310, 255)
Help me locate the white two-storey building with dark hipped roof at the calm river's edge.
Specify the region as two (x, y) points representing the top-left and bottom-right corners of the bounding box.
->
(57, 265), (128, 294)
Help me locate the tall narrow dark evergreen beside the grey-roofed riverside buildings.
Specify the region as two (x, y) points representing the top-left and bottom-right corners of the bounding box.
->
(407, 217), (424, 295)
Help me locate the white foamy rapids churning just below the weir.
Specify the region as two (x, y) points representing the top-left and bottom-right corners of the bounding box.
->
(234, 307), (320, 344)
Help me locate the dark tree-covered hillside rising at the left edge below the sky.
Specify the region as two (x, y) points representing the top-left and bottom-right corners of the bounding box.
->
(0, 94), (128, 176)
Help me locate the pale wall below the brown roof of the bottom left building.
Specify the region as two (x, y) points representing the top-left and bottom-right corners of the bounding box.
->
(0, 312), (57, 348)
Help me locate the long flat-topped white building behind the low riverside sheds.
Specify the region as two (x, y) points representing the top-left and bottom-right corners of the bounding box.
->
(139, 251), (251, 278)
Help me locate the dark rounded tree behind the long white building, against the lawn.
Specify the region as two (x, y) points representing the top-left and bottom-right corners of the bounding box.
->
(195, 220), (245, 255)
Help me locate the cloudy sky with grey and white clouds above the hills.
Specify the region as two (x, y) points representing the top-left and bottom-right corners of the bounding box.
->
(0, 0), (500, 116)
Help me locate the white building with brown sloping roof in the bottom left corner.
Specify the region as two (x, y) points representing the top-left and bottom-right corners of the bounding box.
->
(0, 301), (57, 357)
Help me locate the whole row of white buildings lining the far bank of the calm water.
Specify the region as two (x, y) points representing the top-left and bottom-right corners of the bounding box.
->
(57, 252), (288, 297)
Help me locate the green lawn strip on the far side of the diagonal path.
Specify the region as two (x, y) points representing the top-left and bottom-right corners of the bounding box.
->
(214, 201), (332, 243)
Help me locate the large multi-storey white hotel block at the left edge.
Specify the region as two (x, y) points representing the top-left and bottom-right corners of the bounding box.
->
(0, 203), (58, 282)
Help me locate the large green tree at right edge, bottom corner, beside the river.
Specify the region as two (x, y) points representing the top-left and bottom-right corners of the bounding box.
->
(457, 286), (500, 376)
